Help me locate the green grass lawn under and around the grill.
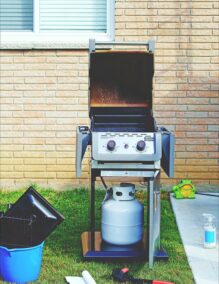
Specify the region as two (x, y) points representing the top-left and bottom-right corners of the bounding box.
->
(0, 186), (194, 284)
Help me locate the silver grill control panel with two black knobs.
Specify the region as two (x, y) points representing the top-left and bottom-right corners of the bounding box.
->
(92, 132), (162, 161)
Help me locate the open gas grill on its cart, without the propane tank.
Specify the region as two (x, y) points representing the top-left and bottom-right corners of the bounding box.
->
(76, 40), (174, 267)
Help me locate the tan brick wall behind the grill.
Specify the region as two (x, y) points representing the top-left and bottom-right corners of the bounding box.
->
(0, 0), (219, 188)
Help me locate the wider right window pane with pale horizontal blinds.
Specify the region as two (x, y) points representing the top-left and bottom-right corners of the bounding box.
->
(40, 0), (107, 32)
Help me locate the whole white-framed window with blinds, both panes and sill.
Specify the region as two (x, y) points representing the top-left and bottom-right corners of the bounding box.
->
(0, 0), (115, 47)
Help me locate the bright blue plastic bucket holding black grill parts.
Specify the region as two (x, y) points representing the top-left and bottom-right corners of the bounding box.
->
(0, 242), (44, 283)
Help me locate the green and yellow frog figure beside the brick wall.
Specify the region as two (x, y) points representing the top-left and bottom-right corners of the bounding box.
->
(173, 179), (196, 199)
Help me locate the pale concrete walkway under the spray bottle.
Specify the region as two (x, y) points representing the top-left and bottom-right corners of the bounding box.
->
(170, 194), (219, 284)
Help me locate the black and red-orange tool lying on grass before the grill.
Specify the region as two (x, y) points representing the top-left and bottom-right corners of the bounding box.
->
(112, 267), (174, 284)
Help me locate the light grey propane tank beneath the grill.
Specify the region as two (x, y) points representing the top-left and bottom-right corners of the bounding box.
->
(101, 183), (144, 245)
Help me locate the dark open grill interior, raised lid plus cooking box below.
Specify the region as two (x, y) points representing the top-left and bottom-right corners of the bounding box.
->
(89, 51), (155, 132)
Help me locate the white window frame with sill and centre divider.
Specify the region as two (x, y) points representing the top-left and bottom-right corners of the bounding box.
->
(0, 0), (115, 48)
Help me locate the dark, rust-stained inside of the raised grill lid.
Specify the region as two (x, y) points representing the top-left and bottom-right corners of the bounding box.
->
(89, 51), (154, 111)
